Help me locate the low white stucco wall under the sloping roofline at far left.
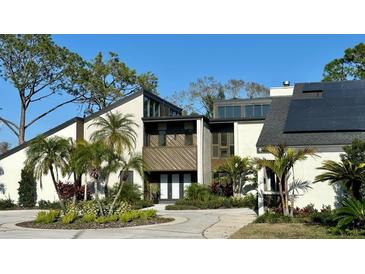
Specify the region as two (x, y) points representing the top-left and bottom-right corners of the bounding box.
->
(0, 122), (76, 202)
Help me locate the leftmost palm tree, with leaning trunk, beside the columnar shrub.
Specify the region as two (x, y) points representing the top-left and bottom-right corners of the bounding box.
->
(25, 135), (69, 209)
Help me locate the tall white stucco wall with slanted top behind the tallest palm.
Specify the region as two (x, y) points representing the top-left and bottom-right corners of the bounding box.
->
(84, 95), (144, 190)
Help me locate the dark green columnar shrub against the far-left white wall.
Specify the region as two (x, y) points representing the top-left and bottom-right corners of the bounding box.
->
(18, 167), (37, 207)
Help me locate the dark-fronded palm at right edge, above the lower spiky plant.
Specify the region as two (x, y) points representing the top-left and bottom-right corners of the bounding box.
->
(314, 159), (365, 200)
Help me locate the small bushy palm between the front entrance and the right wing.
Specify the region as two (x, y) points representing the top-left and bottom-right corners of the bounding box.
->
(216, 156), (255, 194)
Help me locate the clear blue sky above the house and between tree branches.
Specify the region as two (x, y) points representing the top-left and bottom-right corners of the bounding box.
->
(0, 35), (365, 146)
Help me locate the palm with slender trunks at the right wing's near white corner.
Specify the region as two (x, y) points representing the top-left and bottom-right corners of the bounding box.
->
(255, 145), (317, 216)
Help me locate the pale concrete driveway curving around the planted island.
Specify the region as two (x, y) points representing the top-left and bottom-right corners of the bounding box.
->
(0, 205), (256, 239)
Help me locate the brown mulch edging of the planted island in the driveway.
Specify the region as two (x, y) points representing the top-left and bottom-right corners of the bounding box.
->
(16, 217), (174, 229)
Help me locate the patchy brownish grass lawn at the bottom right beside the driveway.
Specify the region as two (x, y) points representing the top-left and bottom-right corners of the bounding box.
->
(230, 223), (365, 239)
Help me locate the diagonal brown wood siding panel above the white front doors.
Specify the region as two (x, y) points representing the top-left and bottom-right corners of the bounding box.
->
(143, 146), (197, 171)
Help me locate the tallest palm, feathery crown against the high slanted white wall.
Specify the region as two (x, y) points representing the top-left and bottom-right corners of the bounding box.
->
(89, 112), (138, 196)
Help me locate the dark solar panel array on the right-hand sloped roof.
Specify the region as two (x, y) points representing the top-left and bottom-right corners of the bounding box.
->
(284, 80), (365, 133)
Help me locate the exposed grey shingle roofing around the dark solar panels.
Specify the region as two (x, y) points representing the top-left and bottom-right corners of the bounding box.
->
(257, 92), (365, 147)
